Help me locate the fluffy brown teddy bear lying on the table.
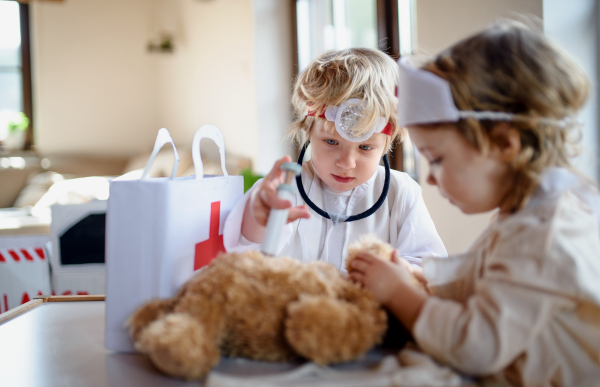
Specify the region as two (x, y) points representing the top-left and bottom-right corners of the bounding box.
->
(128, 236), (393, 380)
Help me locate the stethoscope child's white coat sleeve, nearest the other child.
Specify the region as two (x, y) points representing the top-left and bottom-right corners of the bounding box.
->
(394, 177), (448, 265)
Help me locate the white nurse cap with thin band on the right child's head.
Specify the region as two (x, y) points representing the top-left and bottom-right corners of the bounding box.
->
(398, 57), (574, 127)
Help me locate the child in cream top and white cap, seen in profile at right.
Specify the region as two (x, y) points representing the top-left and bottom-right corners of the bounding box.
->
(350, 21), (600, 387)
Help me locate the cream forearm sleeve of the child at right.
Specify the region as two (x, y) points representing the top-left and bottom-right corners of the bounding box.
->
(413, 281), (551, 375)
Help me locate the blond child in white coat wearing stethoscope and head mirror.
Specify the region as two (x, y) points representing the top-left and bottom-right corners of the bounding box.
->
(223, 48), (446, 270)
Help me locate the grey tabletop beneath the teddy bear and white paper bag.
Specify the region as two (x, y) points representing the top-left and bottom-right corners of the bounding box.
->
(0, 296), (472, 387)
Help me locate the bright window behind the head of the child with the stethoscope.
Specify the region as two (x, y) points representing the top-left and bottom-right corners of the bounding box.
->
(294, 0), (418, 179)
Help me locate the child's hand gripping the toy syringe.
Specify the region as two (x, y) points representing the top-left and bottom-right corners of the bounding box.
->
(249, 156), (310, 227)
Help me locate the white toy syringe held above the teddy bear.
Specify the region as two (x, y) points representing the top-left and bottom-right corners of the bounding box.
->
(260, 163), (302, 256)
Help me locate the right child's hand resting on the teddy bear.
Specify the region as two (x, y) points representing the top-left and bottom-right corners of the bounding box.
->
(350, 251), (415, 305)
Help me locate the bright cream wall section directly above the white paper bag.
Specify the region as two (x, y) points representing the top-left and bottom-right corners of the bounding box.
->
(154, 0), (259, 161)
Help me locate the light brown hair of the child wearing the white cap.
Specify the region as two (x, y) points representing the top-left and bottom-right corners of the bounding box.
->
(423, 20), (589, 211)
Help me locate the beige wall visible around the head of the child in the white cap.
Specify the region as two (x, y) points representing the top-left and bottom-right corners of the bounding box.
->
(417, 0), (542, 253)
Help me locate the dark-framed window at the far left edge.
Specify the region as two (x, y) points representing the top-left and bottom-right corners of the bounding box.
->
(0, 1), (32, 148)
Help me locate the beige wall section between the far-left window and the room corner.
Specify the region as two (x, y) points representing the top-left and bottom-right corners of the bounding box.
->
(31, 0), (157, 158)
